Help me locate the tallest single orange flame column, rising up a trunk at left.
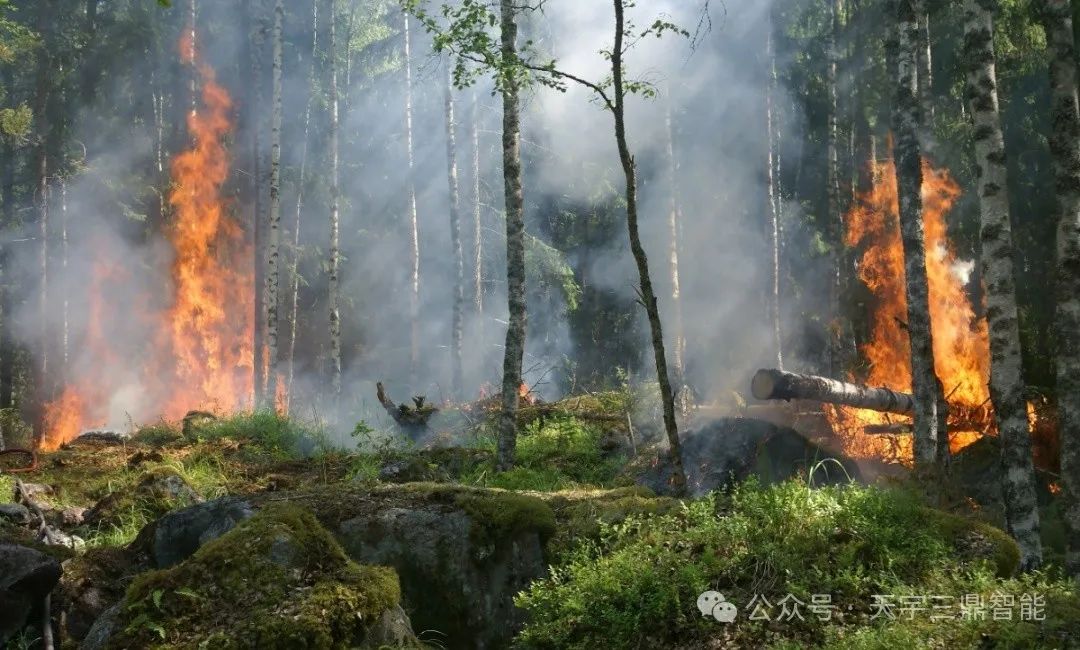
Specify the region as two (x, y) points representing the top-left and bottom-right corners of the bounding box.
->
(161, 36), (254, 418)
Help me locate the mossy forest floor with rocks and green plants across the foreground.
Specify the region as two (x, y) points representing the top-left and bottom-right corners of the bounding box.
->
(0, 398), (1080, 649)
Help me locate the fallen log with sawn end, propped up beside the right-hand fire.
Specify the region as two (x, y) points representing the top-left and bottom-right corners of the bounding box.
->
(751, 368), (915, 415)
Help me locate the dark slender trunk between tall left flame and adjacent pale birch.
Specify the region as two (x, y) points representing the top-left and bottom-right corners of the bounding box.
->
(249, 0), (267, 407)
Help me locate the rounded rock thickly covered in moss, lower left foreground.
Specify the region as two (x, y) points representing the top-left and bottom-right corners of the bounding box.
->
(109, 503), (401, 649)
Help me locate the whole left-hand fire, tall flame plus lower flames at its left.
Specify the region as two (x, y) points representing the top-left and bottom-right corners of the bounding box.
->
(39, 35), (254, 450)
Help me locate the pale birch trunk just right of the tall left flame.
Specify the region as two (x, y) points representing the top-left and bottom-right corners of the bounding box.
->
(261, 0), (285, 409)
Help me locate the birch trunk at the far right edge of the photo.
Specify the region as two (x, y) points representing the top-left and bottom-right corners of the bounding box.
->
(1040, 0), (1080, 578)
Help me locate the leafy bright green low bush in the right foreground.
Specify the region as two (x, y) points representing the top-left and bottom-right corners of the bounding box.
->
(516, 482), (1080, 648)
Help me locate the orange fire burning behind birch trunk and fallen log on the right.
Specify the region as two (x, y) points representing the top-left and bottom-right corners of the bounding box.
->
(826, 156), (995, 463)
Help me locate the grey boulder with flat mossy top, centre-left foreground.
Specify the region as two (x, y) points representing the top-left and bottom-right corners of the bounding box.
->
(306, 483), (555, 648)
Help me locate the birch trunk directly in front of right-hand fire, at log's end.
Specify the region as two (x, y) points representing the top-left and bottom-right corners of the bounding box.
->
(892, 0), (947, 475)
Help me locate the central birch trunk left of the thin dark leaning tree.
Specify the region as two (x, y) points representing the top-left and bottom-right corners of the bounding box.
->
(498, 0), (526, 471)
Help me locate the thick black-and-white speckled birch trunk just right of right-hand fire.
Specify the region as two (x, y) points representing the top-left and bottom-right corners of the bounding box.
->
(963, 0), (1042, 570)
